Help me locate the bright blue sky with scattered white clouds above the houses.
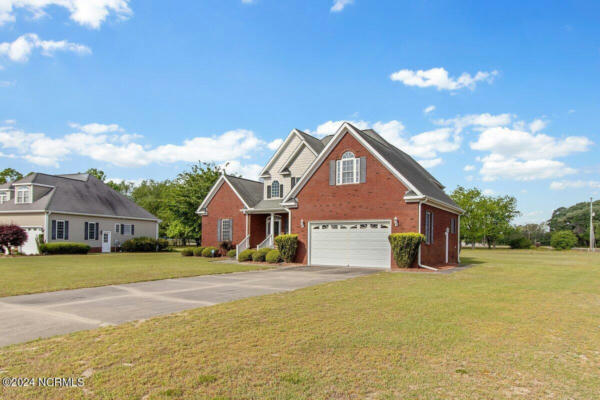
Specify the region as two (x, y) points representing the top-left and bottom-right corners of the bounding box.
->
(0, 0), (600, 222)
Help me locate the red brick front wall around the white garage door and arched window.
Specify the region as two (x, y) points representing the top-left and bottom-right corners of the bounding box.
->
(292, 133), (419, 268)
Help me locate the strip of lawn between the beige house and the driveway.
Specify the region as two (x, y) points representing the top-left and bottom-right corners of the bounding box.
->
(0, 252), (268, 296)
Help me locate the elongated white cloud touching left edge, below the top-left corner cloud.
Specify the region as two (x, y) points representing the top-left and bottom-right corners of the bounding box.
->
(0, 33), (92, 63)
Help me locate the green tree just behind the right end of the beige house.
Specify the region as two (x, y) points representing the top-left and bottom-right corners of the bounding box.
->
(131, 179), (179, 238)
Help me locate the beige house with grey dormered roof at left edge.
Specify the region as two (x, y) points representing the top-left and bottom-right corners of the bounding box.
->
(0, 173), (160, 254)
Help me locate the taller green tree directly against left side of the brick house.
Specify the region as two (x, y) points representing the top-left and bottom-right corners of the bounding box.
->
(169, 163), (222, 244)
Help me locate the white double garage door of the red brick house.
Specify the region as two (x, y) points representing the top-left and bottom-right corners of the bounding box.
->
(309, 221), (391, 268)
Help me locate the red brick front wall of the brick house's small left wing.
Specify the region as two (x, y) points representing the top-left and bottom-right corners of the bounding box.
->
(202, 182), (246, 247)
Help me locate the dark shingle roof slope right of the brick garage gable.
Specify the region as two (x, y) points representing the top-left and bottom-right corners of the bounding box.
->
(354, 127), (458, 207)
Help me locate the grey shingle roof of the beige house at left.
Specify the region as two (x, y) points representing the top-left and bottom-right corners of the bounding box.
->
(0, 173), (158, 221)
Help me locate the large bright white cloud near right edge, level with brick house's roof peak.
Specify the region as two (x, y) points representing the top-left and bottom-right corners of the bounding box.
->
(471, 127), (593, 160)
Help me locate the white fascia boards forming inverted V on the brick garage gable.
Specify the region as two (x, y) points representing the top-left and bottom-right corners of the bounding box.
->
(283, 122), (422, 203)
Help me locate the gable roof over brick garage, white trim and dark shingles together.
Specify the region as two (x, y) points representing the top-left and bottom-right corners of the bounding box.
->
(282, 122), (462, 212)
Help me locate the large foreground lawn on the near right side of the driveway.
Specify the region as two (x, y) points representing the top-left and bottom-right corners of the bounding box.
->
(0, 250), (600, 400)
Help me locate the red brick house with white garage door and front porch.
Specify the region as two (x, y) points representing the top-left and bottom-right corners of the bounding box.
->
(198, 123), (463, 268)
